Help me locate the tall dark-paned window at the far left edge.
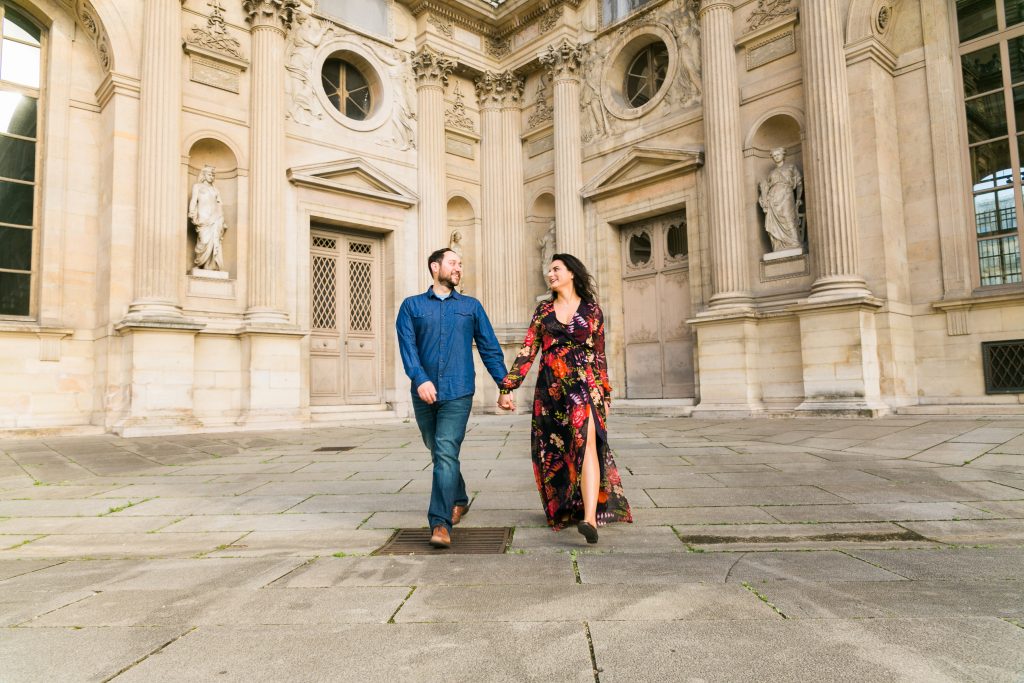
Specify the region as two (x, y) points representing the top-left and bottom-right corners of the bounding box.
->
(0, 2), (41, 315)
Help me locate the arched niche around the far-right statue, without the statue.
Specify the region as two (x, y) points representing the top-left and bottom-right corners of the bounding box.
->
(743, 111), (807, 254)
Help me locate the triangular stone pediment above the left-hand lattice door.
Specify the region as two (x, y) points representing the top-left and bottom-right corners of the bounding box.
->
(288, 158), (418, 207)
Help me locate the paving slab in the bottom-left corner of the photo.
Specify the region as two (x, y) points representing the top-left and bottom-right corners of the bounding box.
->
(0, 628), (184, 683)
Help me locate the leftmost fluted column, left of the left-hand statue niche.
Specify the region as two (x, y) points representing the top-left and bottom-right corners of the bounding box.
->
(129, 0), (184, 318)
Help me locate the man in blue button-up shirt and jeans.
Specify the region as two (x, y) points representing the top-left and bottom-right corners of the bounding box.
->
(395, 248), (506, 548)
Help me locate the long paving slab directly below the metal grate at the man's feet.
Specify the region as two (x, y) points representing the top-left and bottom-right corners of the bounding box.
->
(271, 554), (575, 588)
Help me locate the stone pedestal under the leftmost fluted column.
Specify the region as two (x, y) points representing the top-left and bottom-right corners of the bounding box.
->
(112, 322), (204, 436)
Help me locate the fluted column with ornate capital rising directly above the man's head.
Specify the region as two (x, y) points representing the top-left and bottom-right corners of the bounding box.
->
(413, 46), (455, 276)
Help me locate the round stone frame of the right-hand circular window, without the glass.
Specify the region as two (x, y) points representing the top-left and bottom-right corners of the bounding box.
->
(601, 25), (679, 121)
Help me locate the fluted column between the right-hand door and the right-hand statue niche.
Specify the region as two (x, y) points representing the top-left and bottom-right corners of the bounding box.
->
(700, 0), (751, 308)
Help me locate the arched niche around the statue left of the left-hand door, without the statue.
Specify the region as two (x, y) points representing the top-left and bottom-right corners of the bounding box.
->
(183, 137), (239, 280)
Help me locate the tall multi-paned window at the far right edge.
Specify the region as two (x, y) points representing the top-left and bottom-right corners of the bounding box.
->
(956, 0), (1024, 287)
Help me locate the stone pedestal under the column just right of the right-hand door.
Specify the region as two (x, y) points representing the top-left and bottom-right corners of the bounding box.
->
(686, 312), (764, 418)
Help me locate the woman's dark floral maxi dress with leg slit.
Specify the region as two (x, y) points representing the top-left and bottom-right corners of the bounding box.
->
(501, 301), (633, 530)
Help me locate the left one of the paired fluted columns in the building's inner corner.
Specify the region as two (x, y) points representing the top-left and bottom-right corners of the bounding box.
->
(476, 72), (507, 324)
